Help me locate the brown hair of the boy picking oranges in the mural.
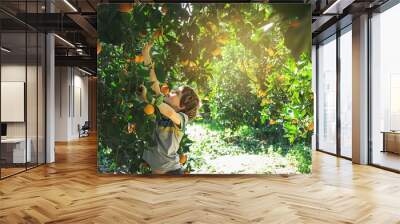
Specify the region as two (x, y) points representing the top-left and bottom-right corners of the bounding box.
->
(180, 86), (200, 120)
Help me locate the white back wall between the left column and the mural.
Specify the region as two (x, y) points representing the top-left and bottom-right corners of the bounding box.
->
(55, 67), (89, 141)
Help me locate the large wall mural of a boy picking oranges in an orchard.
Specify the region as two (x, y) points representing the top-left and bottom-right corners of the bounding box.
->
(97, 3), (314, 175)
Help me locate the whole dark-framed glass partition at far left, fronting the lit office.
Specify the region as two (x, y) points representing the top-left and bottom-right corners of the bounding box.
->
(0, 1), (46, 179)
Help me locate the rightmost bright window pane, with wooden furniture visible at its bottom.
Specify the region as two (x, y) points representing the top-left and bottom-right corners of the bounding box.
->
(371, 4), (400, 170)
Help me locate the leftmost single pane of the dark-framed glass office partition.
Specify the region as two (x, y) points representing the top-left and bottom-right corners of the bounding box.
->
(0, 32), (27, 177)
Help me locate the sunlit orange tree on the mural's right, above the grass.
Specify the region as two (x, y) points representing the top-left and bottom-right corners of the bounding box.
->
(205, 4), (313, 146)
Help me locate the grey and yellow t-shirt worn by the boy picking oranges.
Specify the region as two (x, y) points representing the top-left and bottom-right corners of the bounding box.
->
(143, 112), (189, 172)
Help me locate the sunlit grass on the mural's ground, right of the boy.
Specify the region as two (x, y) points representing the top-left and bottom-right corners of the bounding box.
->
(187, 122), (311, 174)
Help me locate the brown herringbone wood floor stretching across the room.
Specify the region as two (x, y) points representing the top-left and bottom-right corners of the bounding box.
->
(0, 135), (400, 224)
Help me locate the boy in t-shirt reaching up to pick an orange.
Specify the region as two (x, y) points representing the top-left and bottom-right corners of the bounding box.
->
(142, 43), (200, 175)
